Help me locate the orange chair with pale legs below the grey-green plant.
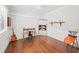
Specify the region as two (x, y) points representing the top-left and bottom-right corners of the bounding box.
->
(64, 34), (78, 52)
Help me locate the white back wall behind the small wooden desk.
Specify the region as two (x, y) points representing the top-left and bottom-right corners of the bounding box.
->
(11, 14), (38, 39)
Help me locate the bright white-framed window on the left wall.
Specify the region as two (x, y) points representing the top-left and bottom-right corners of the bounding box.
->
(0, 6), (7, 33)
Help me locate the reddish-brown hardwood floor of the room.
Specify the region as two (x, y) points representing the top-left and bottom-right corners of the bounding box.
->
(5, 36), (78, 53)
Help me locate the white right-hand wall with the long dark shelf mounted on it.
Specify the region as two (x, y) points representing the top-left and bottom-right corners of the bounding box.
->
(42, 6), (79, 41)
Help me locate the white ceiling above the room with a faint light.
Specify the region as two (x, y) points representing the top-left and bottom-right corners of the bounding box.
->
(7, 5), (64, 15)
